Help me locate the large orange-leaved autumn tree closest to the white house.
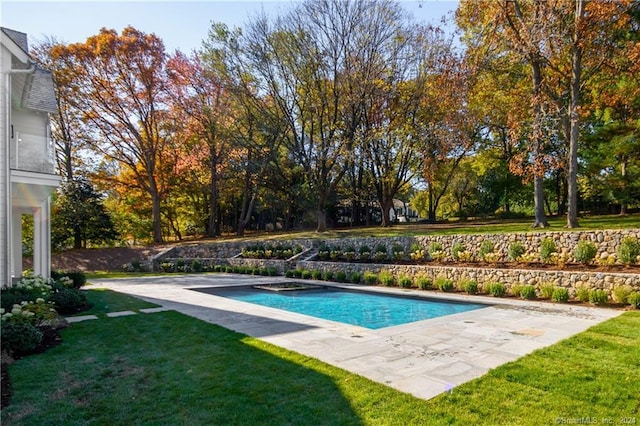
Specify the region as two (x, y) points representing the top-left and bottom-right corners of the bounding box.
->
(52, 27), (173, 242)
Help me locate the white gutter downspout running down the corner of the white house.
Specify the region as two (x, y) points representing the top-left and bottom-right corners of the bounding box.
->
(0, 61), (36, 287)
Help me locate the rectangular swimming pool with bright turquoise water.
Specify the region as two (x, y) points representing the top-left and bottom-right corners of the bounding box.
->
(194, 287), (487, 330)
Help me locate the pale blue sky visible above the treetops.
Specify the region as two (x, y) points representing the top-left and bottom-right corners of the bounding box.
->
(0, 0), (458, 53)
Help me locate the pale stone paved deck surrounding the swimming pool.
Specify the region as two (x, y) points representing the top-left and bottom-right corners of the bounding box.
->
(88, 274), (621, 399)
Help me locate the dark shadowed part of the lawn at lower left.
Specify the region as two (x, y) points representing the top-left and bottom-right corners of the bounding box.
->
(2, 311), (364, 425)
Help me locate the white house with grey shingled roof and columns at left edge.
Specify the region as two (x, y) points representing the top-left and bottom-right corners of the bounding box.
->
(0, 28), (60, 287)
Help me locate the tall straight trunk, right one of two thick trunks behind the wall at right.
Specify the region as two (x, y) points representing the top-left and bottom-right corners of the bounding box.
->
(567, 0), (584, 228)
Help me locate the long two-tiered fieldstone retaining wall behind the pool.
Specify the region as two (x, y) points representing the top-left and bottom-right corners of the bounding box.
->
(150, 228), (640, 296)
